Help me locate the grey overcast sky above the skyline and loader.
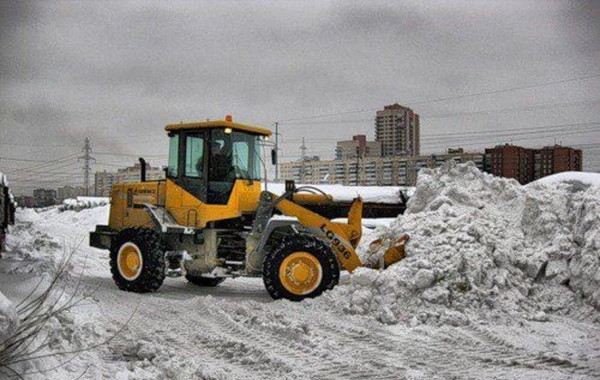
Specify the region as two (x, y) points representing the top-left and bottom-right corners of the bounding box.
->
(0, 0), (600, 194)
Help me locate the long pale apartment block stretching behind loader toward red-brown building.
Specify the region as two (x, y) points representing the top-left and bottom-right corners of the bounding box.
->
(280, 153), (483, 186)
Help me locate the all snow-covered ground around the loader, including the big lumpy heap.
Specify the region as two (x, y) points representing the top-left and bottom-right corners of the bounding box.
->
(0, 164), (600, 380)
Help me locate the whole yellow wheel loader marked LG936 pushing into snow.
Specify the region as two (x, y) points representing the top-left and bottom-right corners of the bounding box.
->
(90, 117), (406, 301)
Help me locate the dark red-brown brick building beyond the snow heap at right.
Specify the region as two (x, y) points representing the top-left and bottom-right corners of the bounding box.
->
(484, 144), (582, 185)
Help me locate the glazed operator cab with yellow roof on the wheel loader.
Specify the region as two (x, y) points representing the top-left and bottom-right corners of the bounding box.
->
(166, 120), (271, 205)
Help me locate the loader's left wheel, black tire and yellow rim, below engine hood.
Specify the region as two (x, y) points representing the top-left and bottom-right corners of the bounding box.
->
(110, 227), (165, 293)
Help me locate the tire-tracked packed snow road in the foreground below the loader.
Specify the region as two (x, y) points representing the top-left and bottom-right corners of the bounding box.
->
(0, 264), (600, 379)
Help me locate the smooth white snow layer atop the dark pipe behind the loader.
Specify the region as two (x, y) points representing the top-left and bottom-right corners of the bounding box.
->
(262, 183), (414, 204)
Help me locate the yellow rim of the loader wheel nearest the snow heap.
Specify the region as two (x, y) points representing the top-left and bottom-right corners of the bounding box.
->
(279, 252), (323, 295)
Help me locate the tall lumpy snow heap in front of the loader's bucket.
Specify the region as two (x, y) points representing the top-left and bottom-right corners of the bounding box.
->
(317, 162), (600, 325)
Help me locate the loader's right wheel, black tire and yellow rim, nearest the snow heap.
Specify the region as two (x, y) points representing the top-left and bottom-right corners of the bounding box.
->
(263, 235), (340, 301)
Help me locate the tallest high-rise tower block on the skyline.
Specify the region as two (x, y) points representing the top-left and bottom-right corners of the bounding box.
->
(375, 103), (421, 157)
